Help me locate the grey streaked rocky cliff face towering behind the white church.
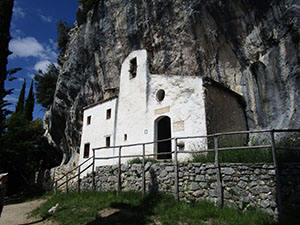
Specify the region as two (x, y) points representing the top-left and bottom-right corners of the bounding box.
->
(45, 0), (300, 162)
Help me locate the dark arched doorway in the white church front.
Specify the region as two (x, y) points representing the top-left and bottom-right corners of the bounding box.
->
(155, 116), (172, 159)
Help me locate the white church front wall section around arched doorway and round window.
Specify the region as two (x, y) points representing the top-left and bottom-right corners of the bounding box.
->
(148, 75), (206, 160)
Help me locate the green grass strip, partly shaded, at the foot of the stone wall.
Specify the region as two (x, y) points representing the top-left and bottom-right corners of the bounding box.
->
(33, 192), (272, 225)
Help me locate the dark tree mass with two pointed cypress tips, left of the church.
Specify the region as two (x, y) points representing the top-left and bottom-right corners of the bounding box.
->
(0, 78), (56, 193)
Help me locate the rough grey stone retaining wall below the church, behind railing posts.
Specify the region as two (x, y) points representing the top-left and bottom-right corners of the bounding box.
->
(77, 162), (300, 218)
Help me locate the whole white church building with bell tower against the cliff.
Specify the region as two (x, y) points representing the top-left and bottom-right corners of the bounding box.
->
(79, 50), (247, 175)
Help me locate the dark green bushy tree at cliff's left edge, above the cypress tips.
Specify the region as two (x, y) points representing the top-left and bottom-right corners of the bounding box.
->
(34, 64), (58, 108)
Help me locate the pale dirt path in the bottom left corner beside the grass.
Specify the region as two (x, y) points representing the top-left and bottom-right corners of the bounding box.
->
(0, 200), (58, 225)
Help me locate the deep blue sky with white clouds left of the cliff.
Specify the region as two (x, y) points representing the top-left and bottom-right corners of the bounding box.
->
(5, 0), (78, 119)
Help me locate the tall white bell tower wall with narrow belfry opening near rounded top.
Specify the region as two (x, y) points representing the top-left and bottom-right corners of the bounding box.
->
(116, 50), (153, 158)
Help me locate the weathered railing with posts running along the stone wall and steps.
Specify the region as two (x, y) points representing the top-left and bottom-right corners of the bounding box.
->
(55, 129), (300, 202)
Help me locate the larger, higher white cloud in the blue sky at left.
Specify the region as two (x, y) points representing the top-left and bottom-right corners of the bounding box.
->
(9, 37), (45, 58)
